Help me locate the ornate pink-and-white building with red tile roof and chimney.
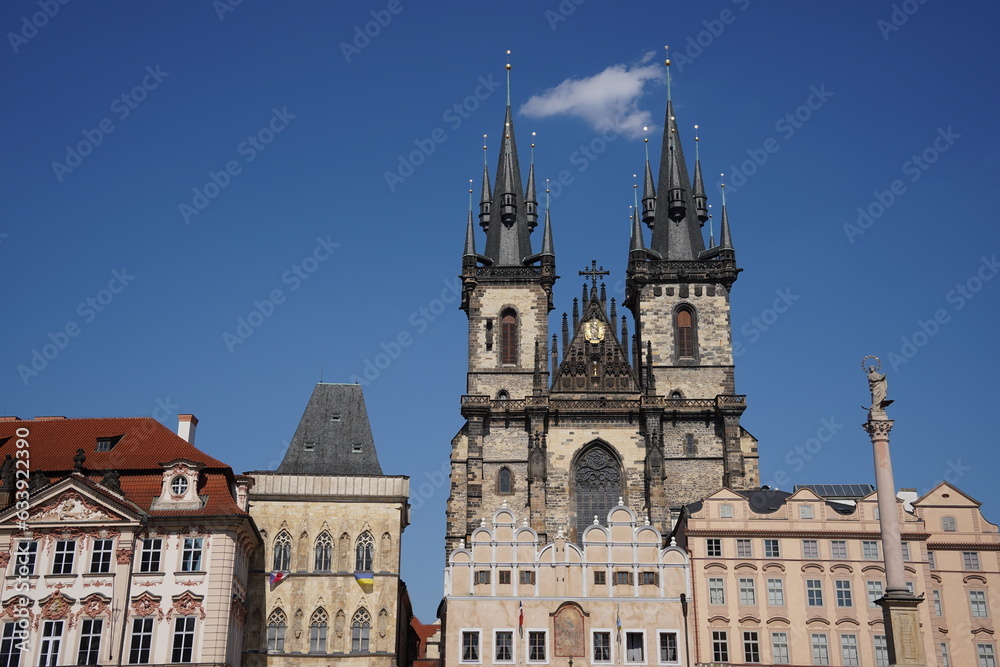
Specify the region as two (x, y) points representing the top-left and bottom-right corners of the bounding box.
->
(0, 415), (260, 667)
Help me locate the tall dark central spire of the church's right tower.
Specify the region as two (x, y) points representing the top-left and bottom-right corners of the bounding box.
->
(652, 49), (705, 261)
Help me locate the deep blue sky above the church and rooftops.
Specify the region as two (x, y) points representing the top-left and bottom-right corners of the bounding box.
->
(0, 0), (1000, 621)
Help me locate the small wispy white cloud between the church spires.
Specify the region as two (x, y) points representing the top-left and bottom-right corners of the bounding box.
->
(521, 61), (663, 138)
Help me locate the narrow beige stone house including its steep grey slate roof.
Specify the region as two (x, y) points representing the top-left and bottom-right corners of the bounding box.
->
(243, 383), (412, 667)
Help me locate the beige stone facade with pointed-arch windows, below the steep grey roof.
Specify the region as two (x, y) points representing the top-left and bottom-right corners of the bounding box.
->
(244, 472), (412, 667)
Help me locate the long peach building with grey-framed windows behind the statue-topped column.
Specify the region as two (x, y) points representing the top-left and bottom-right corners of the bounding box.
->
(676, 483), (1000, 666)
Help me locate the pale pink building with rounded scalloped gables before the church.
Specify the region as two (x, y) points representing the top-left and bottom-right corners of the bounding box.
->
(441, 504), (690, 665)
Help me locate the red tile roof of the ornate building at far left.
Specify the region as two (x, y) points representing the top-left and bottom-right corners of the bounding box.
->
(0, 417), (246, 516)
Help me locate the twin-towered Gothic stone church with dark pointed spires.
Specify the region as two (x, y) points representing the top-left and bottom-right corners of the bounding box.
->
(446, 61), (758, 552)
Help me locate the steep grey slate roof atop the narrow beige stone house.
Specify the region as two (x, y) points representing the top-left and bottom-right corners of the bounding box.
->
(278, 382), (382, 475)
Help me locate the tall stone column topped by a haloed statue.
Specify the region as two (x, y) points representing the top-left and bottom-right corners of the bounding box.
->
(861, 357), (926, 665)
